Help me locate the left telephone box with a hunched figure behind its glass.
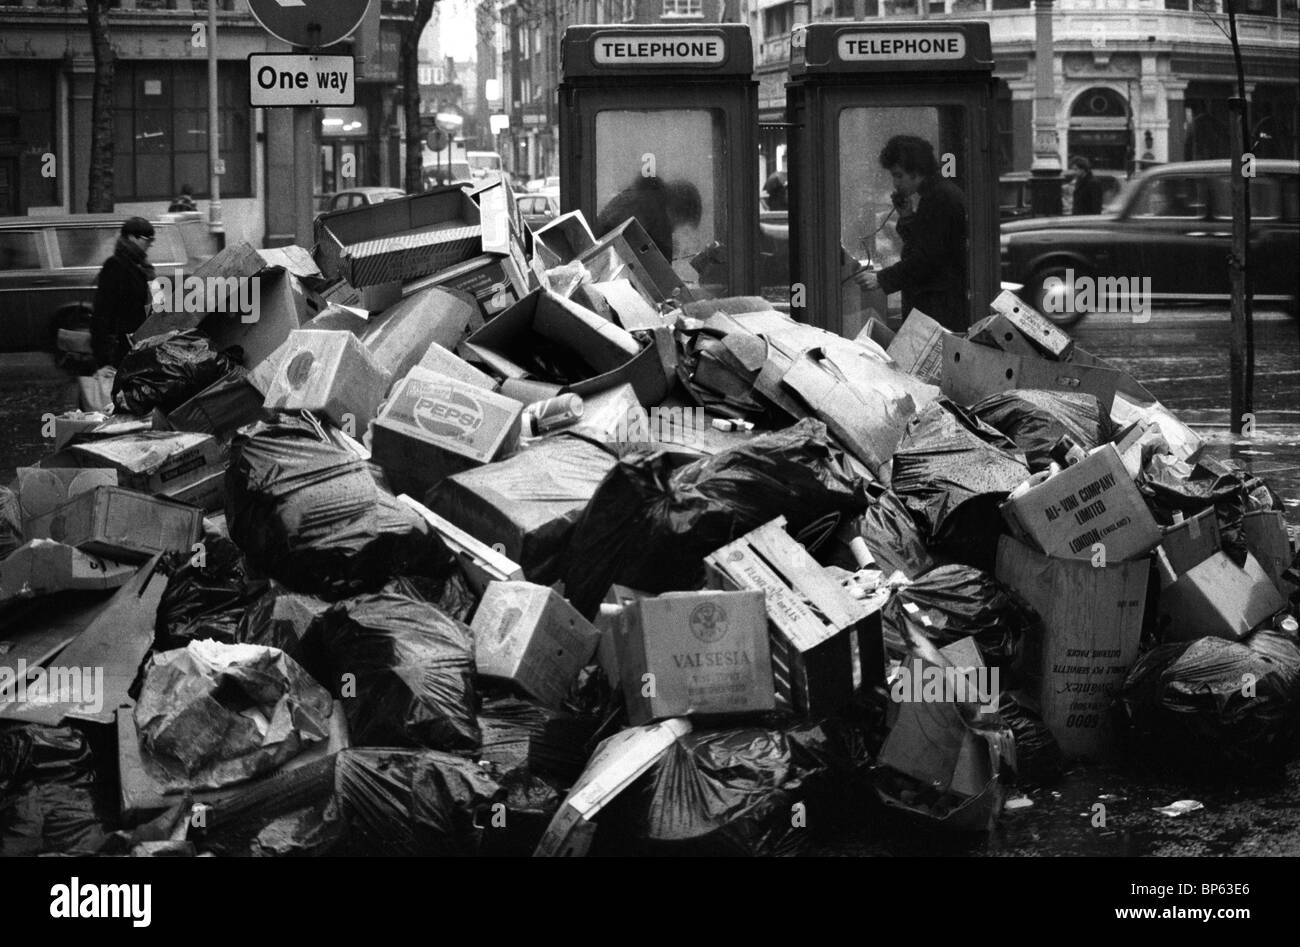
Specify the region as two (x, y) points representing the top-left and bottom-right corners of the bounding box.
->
(559, 23), (761, 298)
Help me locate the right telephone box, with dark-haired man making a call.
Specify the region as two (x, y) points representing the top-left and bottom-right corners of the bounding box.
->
(787, 20), (1000, 337)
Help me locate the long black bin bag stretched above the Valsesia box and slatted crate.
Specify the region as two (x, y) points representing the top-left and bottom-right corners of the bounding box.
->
(564, 420), (866, 618)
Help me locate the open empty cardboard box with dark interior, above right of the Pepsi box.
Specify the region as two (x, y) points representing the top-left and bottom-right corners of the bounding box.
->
(462, 290), (677, 405)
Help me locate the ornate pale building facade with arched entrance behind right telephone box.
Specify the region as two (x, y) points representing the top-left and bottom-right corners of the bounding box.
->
(745, 0), (1300, 182)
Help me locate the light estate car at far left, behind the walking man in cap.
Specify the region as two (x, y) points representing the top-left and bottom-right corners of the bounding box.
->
(0, 213), (195, 351)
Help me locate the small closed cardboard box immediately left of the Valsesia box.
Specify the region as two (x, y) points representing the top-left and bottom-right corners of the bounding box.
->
(471, 581), (599, 710)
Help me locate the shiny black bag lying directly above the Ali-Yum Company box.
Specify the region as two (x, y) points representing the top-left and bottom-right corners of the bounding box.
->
(971, 389), (1114, 474)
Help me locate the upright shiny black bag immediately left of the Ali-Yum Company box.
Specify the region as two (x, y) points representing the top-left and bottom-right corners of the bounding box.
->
(889, 398), (1030, 571)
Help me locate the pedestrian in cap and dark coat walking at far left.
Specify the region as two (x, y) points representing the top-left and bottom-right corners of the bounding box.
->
(90, 217), (155, 368)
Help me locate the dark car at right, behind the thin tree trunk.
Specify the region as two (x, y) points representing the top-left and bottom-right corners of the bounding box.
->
(1001, 160), (1300, 324)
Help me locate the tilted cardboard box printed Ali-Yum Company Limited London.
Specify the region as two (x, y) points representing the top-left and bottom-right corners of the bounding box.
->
(1002, 444), (1161, 562)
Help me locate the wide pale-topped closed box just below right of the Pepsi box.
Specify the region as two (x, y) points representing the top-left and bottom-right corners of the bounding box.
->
(432, 434), (618, 579)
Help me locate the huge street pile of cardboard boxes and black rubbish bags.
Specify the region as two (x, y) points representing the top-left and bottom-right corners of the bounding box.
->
(0, 181), (1300, 856)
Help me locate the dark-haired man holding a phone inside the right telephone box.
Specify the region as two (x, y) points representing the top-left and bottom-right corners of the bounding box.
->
(853, 135), (970, 332)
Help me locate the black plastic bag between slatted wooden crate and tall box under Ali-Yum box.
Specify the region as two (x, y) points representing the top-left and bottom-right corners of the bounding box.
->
(881, 565), (1036, 671)
